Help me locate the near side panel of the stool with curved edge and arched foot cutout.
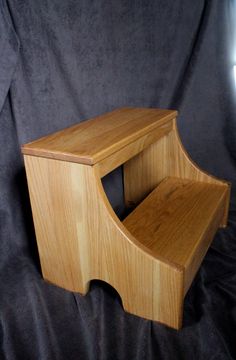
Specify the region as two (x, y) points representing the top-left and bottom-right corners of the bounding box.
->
(25, 155), (183, 328)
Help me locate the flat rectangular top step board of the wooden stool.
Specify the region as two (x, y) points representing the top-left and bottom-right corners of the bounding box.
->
(22, 108), (177, 165)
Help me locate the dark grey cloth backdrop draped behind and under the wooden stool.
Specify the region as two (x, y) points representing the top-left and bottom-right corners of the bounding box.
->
(0, 0), (236, 360)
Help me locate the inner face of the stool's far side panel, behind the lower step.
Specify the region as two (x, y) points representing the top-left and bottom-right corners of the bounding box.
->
(124, 120), (230, 222)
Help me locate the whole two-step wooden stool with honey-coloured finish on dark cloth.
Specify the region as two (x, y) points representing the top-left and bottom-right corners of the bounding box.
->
(22, 108), (230, 329)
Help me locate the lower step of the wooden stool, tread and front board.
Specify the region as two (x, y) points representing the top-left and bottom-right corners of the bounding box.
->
(123, 178), (228, 289)
